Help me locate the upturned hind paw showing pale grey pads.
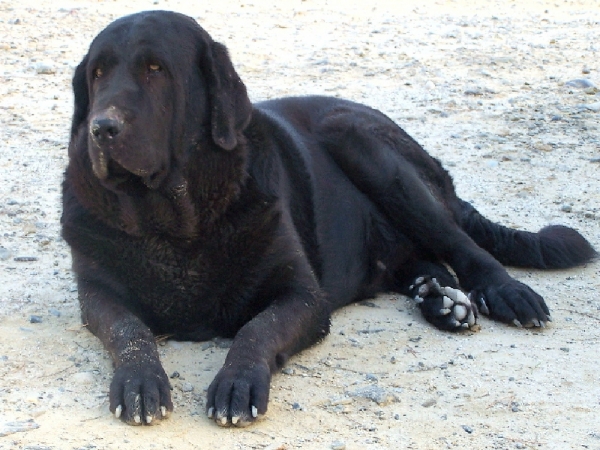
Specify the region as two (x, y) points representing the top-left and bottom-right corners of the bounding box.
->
(410, 277), (477, 331)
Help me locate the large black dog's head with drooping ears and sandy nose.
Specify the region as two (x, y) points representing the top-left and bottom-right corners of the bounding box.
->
(71, 11), (252, 191)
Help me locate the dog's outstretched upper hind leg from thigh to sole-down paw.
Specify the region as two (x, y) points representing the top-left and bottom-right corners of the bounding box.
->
(318, 106), (550, 326)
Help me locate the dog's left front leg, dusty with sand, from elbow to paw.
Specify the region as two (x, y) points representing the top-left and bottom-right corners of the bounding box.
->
(78, 260), (173, 425)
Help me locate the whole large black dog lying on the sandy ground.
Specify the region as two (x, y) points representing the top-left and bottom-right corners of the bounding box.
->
(62, 12), (596, 426)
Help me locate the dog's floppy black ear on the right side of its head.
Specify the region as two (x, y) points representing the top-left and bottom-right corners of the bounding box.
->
(201, 40), (252, 150)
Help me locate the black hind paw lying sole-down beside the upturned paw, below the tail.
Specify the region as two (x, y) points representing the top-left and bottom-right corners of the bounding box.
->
(469, 279), (552, 327)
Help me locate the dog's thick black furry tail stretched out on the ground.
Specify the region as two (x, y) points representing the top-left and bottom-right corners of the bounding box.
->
(461, 200), (598, 269)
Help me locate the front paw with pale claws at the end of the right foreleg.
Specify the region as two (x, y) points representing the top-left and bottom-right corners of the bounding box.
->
(206, 362), (271, 427)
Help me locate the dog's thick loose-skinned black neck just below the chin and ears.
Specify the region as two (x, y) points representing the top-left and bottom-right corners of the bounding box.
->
(67, 142), (247, 246)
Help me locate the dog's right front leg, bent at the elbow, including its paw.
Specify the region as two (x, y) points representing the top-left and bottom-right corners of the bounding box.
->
(206, 287), (329, 426)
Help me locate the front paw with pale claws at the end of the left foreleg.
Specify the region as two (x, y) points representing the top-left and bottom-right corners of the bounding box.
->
(109, 361), (173, 425)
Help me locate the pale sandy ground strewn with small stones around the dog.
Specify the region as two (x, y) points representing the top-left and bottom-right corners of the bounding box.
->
(0, 0), (600, 450)
